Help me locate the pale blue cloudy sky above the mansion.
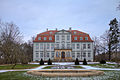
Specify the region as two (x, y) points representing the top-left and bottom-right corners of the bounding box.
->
(0, 0), (120, 41)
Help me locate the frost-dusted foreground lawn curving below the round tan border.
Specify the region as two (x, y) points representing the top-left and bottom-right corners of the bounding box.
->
(0, 71), (120, 80)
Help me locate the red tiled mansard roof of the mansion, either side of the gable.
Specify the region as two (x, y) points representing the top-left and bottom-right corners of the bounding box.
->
(33, 30), (93, 42)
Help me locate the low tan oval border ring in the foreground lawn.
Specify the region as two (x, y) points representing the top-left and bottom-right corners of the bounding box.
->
(27, 69), (104, 77)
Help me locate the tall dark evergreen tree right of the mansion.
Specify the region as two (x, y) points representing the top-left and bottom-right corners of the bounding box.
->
(108, 18), (119, 60)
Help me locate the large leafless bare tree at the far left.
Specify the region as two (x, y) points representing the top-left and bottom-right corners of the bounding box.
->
(0, 21), (22, 68)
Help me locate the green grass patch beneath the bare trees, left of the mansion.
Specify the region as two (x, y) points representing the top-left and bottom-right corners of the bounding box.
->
(0, 64), (40, 70)
